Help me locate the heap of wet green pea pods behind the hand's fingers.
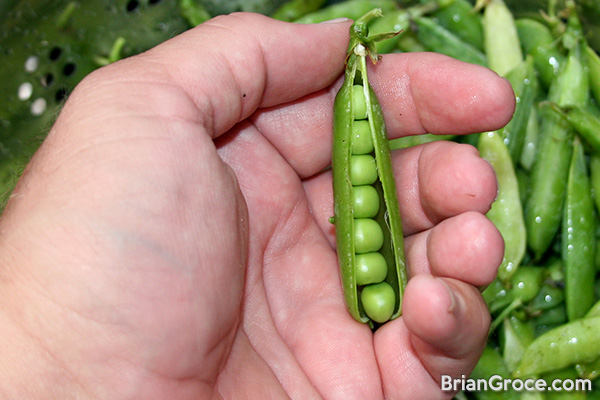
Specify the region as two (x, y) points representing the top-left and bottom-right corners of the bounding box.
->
(274, 0), (600, 400)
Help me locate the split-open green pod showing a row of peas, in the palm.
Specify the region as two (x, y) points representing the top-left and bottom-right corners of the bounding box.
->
(332, 9), (407, 327)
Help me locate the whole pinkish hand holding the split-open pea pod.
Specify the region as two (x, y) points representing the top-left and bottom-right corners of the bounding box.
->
(0, 14), (514, 399)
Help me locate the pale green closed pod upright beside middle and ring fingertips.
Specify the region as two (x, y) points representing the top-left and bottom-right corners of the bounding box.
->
(478, 132), (526, 281)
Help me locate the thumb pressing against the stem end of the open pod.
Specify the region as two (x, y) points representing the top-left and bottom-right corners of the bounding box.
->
(83, 13), (351, 137)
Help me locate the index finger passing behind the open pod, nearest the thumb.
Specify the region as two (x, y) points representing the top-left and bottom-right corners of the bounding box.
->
(254, 53), (515, 177)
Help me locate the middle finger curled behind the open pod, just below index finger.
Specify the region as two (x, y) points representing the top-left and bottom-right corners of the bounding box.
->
(304, 141), (497, 241)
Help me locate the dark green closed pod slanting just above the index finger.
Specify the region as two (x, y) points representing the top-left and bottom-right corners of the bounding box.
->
(415, 17), (487, 66)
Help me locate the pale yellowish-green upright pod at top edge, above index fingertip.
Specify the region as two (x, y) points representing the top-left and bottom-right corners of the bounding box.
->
(482, 0), (523, 76)
